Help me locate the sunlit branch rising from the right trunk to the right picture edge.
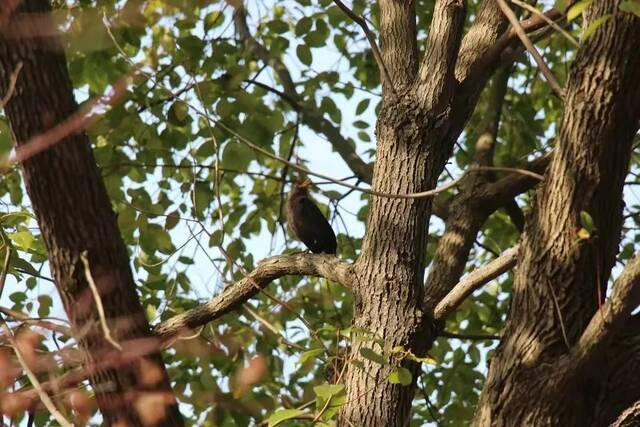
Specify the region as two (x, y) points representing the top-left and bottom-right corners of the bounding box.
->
(572, 253), (640, 366)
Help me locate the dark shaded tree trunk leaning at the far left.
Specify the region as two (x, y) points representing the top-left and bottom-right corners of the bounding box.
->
(0, 0), (182, 425)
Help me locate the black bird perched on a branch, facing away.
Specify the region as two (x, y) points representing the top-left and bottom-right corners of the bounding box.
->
(287, 179), (337, 254)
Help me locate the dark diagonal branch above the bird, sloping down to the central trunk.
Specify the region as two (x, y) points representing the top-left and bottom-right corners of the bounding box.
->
(234, 2), (373, 184)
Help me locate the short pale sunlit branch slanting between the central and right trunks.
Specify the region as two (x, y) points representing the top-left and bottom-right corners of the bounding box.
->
(433, 245), (519, 322)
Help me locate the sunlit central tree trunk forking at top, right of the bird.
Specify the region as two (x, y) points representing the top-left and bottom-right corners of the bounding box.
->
(341, 0), (465, 426)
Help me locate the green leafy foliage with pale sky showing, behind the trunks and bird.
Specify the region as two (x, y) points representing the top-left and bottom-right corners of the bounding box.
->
(0, 0), (640, 426)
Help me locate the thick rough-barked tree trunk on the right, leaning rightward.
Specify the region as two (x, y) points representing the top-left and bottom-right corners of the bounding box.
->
(475, 0), (640, 426)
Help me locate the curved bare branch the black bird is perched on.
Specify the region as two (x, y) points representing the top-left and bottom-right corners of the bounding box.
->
(154, 253), (354, 338)
